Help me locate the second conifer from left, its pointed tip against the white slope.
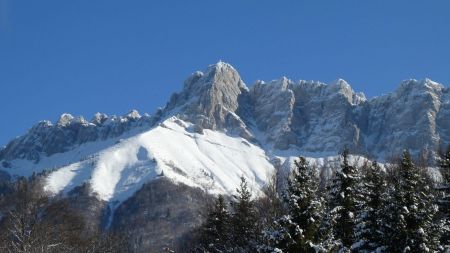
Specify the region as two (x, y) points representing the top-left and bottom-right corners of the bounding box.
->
(231, 176), (258, 252)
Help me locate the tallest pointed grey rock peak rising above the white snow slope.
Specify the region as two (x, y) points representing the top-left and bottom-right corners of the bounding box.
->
(163, 62), (248, 135)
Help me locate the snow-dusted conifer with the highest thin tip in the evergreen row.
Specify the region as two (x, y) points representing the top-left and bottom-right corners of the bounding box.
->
(328, 149), (359, 252)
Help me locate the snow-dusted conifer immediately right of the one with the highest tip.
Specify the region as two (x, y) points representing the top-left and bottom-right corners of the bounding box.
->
(353, 162), (389, 252)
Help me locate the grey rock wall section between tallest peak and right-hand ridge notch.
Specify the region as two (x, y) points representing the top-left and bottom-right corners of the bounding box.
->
(250, 78), (366, 152)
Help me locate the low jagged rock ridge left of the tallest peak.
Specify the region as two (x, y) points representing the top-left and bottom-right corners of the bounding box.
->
(0, 110), (152, 161)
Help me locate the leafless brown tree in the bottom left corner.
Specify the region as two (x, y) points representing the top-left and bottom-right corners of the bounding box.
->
(1, 179), (84, 253)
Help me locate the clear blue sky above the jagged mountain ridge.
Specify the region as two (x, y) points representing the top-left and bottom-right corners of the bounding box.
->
(0, 0), (450, 145)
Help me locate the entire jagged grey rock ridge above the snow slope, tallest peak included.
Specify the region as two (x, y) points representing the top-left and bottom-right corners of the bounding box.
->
(0, 62), (450, 161)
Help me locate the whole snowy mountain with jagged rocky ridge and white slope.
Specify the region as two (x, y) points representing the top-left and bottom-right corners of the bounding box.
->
(0, 62), (450, 251)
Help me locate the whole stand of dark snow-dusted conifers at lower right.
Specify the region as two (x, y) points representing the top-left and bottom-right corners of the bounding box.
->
(190, 148), (450, 253)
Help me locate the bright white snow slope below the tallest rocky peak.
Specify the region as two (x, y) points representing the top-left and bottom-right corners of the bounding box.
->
(41, 117), (274, 202)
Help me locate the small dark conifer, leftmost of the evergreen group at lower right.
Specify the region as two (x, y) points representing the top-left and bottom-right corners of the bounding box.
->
(201, 195), (230, 252)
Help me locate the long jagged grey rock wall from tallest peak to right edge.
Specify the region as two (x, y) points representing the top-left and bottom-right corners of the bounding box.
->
(246, 78), (450, 158)
